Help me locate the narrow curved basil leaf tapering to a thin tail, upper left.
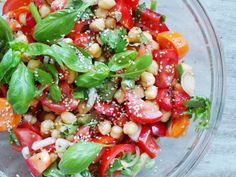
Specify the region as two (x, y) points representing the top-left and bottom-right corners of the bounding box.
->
(27, 43), (64, 69)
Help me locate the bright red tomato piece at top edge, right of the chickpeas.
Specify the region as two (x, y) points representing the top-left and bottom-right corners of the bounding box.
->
(114, 0), (134, 29)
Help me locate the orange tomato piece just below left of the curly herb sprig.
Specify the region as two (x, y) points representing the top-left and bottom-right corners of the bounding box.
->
(167, 115), (190, 138)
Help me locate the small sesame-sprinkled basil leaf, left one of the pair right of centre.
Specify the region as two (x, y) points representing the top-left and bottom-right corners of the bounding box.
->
(108, 50), (138, 71)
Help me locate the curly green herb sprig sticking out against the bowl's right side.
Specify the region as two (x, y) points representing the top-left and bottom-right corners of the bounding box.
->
(185, 97), (211, 130)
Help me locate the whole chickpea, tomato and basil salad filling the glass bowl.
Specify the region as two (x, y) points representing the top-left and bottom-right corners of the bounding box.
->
(0, 0), (211, 177)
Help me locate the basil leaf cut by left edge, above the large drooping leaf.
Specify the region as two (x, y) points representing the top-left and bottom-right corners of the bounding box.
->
(0, 49), (20, 81)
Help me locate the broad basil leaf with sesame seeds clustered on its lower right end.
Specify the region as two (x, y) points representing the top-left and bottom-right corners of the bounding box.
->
(52, 42), (92, 73)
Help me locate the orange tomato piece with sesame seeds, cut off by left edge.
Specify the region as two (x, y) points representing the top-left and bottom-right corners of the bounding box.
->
(0, 98), (21, 132)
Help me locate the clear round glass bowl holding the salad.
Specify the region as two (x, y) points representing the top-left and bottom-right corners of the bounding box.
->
(0, 0), (225, 177)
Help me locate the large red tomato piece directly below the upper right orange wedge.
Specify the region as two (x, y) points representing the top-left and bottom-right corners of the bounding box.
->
(153, 49), (178, 88)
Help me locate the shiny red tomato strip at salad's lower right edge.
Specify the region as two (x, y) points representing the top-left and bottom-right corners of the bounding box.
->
(137, 126), (160, 158)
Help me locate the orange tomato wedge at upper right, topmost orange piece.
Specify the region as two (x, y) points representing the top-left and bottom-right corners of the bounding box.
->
(157, 31), (189, 58)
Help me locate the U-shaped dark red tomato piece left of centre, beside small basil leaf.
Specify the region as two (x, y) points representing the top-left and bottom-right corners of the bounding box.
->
(39, 81), (79, 113)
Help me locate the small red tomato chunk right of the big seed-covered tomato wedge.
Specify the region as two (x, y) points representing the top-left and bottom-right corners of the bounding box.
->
(156, 89), (173, 111)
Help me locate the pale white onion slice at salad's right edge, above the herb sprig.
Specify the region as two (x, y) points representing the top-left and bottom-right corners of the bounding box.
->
(181, 71), (195, 96)
